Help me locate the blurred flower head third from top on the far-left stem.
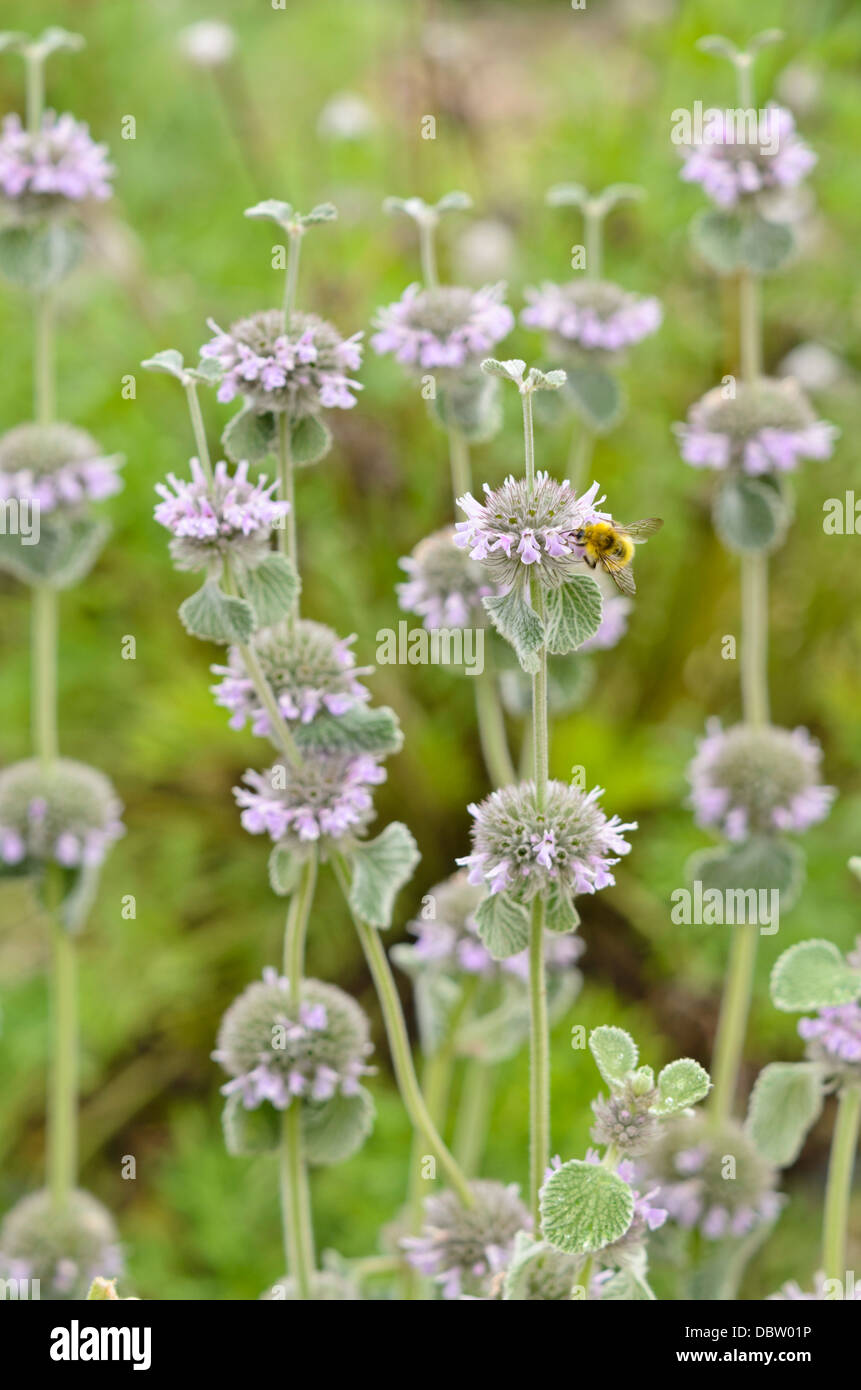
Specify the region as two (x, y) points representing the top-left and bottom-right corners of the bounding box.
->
(0, 758), (125, 869)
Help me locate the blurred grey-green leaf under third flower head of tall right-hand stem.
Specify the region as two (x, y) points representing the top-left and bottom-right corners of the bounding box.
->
(686, 835), (804, 922)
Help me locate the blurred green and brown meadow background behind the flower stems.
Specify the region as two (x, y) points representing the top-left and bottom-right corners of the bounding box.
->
(0, 0), (861, 1298)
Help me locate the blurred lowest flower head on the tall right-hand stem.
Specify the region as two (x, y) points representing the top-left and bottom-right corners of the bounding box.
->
(643, 1112), (780, 1240)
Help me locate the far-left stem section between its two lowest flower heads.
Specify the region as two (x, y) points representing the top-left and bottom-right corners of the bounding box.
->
(47, 922), (78, 1211)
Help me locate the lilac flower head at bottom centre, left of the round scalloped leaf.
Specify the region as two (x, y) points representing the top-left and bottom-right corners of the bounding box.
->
(401, 1180), (531, 1298)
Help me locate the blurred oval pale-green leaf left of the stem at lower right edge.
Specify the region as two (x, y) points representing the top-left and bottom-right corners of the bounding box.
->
(747, 1062), (823, 1168)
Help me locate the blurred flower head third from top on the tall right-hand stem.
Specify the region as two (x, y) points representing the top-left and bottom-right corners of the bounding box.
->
(687, 720), (836, 841)
